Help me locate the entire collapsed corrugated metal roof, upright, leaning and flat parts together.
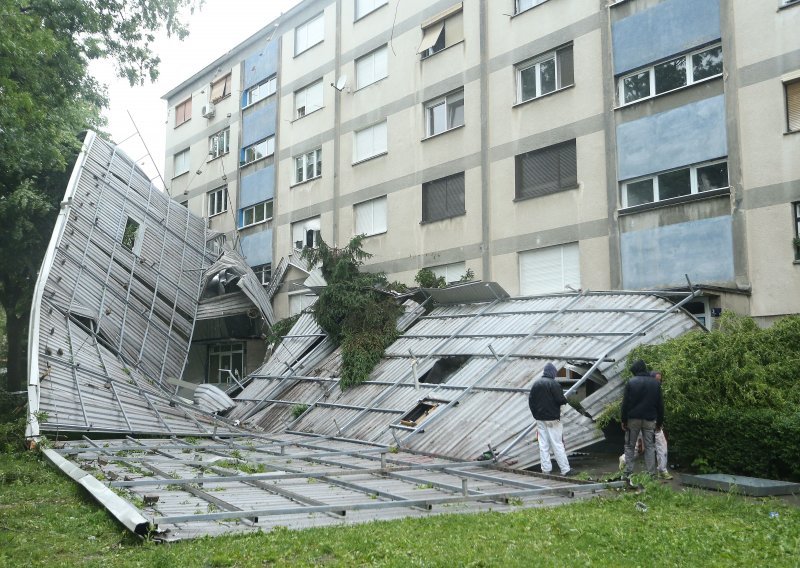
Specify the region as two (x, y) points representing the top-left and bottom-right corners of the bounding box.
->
(28, 133), (702, 538)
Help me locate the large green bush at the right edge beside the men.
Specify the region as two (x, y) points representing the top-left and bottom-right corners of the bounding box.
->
(610, 312), (800, 479)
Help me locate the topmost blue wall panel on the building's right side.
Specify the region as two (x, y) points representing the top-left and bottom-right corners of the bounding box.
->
(611, 0), (720, 75)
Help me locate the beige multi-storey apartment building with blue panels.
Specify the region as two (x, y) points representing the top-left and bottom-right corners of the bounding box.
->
(165, 0), (800, 350)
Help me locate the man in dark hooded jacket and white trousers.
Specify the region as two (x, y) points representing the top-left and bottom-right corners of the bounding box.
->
(528, 363), (575, 476)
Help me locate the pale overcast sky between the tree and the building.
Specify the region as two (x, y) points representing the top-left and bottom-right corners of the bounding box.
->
(91, 0), (300, 191)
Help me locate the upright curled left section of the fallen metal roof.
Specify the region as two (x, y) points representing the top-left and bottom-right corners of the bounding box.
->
(28, 132), (272, 436)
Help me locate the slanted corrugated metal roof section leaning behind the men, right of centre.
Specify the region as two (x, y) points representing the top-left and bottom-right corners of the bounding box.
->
(242, 292), (701, 468)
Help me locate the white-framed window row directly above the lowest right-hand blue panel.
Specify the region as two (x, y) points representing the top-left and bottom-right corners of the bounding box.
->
(622, 161), (728, 207)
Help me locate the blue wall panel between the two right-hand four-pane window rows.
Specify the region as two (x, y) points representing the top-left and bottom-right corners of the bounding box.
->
(617, 95), (728, 180)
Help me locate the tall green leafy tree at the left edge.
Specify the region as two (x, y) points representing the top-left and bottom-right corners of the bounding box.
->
(0, 0), (202, 390)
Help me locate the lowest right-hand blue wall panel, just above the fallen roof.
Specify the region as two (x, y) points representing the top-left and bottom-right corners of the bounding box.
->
(620, 215), (735, 290)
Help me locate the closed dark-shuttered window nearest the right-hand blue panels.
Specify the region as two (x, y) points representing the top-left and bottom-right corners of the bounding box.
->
(516, 140), (578, 199)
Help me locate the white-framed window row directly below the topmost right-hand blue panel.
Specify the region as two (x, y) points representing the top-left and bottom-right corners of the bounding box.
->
(619, 45), (722, 104)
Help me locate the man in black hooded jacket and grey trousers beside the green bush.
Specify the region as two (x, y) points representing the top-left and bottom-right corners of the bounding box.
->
(622, 359), (664, 477)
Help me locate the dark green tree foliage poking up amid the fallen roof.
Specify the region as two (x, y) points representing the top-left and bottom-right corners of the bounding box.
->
(302, 235), (402, 388)
